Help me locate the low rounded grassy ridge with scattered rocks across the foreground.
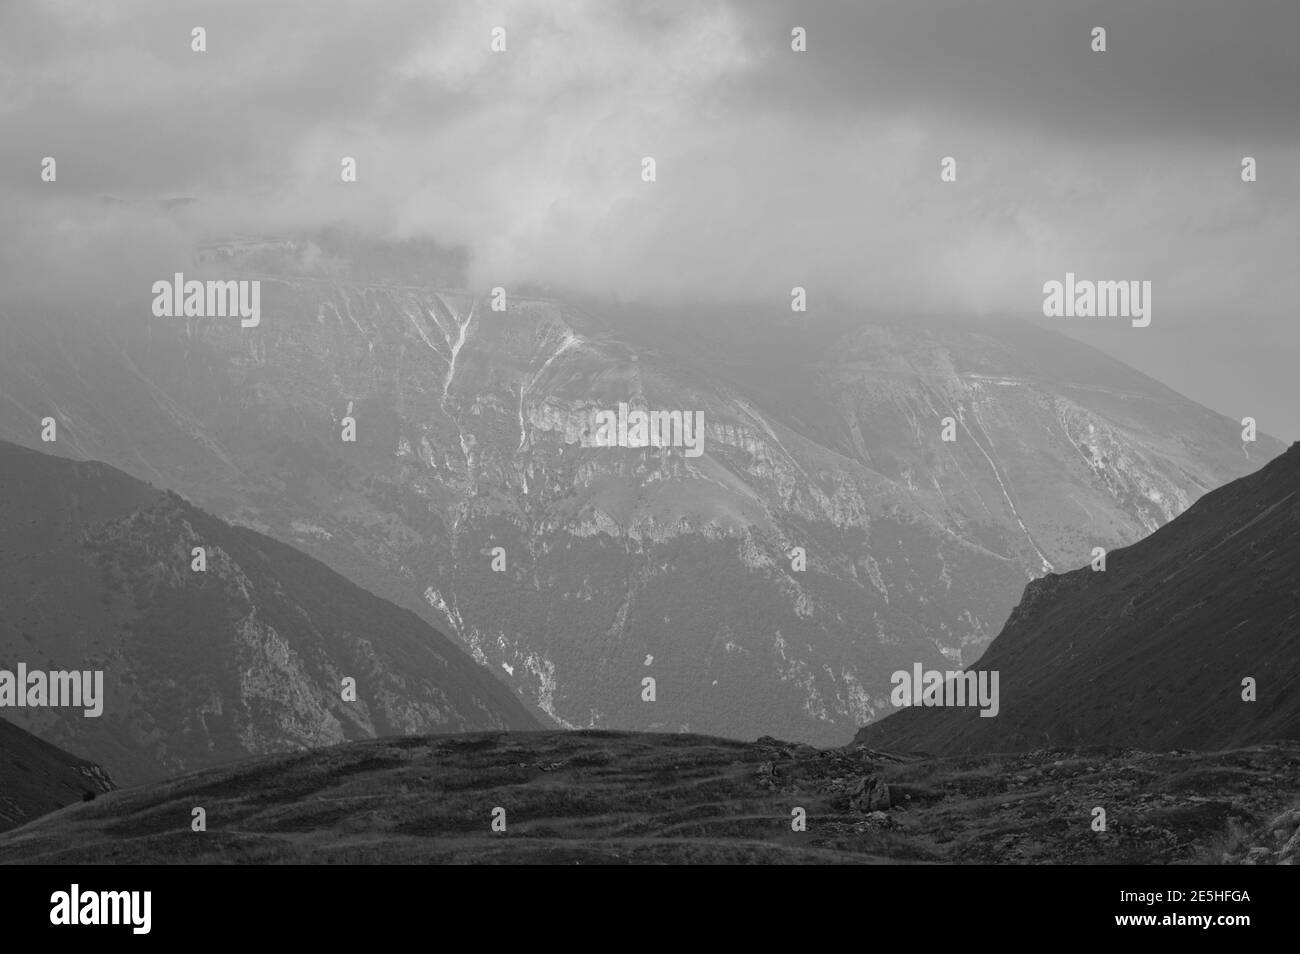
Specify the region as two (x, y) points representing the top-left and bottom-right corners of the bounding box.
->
(0, 730), (1300, 864)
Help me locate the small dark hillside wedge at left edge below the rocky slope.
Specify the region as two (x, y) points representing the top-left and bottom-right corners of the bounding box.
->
(0, 719), (114, 832)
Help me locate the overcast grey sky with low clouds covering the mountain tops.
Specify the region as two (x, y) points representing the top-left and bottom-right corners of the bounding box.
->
(0, 0), (1300, 439)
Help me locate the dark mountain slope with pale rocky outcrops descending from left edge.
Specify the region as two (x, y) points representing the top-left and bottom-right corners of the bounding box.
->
(0, 442), (537, 784)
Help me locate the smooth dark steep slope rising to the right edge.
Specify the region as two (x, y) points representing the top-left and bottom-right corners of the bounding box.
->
(857, 443), (1300, 754)
